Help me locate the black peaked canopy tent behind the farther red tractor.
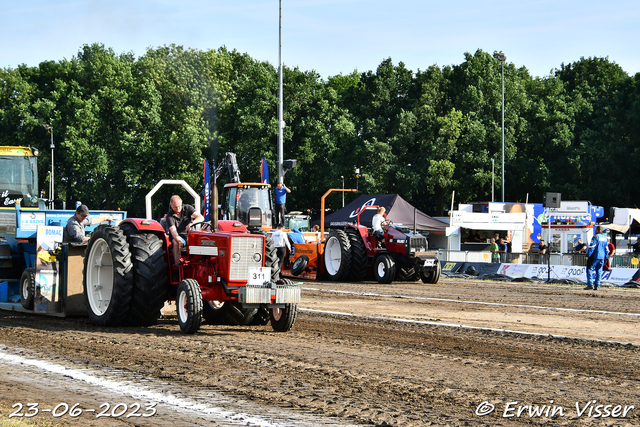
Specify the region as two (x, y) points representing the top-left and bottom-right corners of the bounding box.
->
(316, 194), (448, 233)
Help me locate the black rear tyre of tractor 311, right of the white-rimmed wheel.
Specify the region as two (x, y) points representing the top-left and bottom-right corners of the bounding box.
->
(128, 233), (169, 326)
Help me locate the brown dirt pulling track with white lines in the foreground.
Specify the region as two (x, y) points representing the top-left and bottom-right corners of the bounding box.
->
(0, 279), (640, 426)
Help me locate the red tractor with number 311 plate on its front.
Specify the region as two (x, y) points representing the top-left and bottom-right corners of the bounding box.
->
(84, 219), (300, 333)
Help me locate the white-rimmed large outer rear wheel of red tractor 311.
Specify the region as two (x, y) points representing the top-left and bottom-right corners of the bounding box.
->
(83, 225), (133, 326)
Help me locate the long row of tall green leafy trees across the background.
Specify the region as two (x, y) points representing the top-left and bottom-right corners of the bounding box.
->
(0, 44), (640, 216)
